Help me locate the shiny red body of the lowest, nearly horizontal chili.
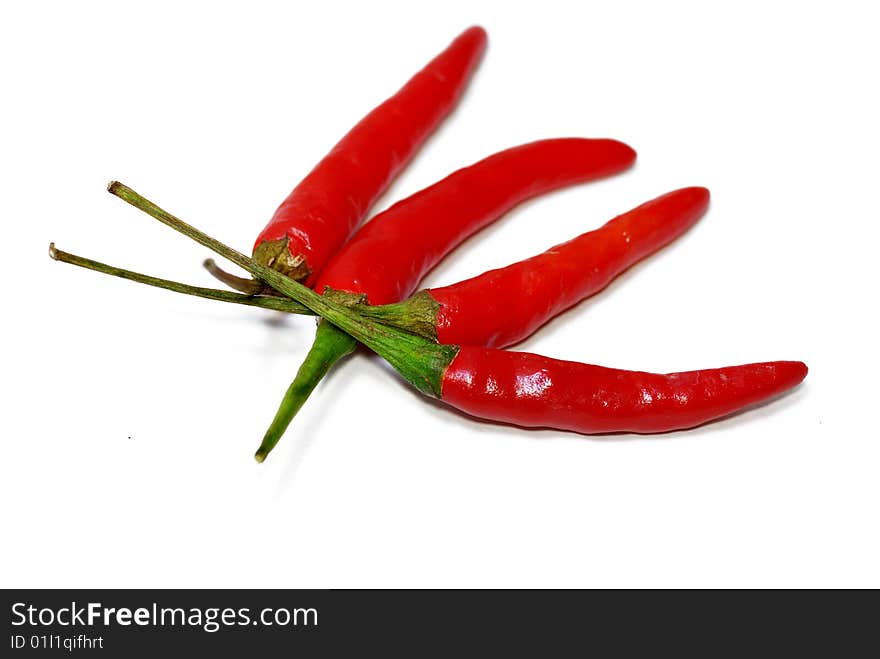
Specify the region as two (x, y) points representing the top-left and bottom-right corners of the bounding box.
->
(440, 346), (807, 434)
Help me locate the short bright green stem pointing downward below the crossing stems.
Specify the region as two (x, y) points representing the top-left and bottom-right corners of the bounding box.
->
(254, 320), (357, 462)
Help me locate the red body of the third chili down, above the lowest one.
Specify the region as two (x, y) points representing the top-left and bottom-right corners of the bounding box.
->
(428, 187), (709, 348)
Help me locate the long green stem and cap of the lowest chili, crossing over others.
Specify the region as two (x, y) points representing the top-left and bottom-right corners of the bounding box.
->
(107, 181), (459, 397)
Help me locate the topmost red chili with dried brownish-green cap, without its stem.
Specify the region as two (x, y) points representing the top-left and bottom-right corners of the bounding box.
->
(254, 27), (486, 283)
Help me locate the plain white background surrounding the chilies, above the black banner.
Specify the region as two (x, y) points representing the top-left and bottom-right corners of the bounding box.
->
(0, 0), (880, 587)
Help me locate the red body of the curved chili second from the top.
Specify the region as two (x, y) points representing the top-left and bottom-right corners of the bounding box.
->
(315, 138), (636, 305)
